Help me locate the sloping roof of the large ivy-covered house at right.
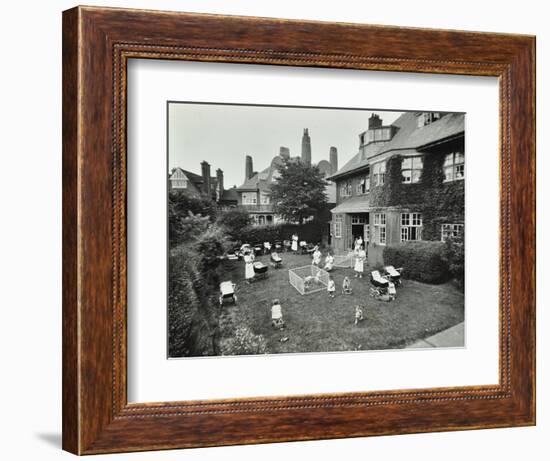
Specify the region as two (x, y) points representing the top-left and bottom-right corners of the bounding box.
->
(329, 112), (464, 179)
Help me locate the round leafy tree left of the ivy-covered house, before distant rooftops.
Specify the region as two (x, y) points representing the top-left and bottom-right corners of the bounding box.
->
(271, 159), (328, 224)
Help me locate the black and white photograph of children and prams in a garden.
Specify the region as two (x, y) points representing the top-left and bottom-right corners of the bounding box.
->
(167, 101), (467, 358)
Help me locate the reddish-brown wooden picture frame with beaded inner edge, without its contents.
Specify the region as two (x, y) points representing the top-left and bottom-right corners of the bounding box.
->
(63, 7), (535, 454)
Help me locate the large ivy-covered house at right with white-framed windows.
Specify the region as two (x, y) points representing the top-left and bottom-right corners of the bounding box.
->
(329, 112), (465, 265)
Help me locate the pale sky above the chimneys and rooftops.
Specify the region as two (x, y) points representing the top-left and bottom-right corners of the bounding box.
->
(168, 102), (402, 189)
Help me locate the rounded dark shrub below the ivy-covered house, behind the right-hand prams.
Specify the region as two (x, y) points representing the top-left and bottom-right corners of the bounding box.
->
(383, 241), (450, 283)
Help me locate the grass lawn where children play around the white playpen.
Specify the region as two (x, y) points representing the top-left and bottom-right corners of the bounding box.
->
(221, 253), (464, 353)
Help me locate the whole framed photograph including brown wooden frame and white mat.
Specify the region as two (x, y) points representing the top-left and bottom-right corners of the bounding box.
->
(63, 7), (535, 454)
